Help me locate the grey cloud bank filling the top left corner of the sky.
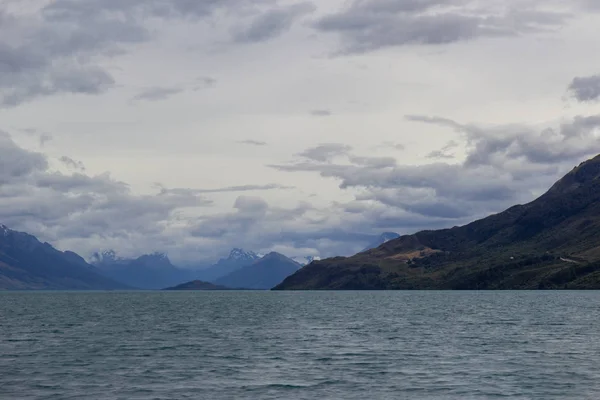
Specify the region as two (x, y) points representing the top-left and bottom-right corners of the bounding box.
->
(0, 0), (273, 107)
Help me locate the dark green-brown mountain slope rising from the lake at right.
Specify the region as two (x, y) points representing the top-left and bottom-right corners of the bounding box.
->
(276, 156), (600, 289)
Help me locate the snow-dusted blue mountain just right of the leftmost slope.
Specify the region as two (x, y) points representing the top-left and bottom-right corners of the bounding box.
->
(92, 250), (194, 290)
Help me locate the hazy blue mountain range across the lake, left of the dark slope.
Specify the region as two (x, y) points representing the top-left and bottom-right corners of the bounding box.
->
(0, 233), (308, 290)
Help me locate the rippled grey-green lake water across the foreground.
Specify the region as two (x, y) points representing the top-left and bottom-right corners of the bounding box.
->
(0, 292), (600, 400)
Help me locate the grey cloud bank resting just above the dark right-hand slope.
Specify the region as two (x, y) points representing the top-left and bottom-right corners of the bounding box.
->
(272, 112), (600, 229)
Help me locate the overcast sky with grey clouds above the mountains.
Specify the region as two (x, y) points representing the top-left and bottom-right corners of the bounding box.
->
(0, 0), (600, 265)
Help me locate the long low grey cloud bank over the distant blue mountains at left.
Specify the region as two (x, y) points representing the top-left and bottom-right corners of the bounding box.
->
(0, 134), (386, 262)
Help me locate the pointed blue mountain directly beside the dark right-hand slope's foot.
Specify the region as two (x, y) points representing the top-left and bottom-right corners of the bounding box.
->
(215, 253), (301, 289)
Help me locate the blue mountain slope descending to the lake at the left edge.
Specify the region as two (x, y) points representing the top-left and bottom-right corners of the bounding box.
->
(0, 225), (127, 290)
